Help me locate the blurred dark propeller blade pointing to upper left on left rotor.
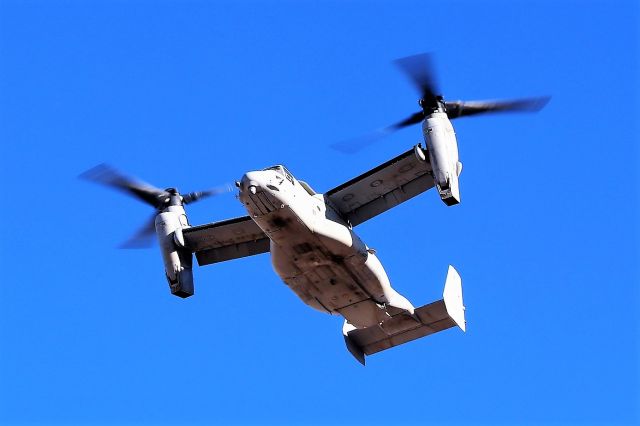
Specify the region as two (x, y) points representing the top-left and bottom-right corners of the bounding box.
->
(79, 164), (169, 208)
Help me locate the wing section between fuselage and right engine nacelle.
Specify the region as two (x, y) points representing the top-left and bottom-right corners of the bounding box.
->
(324, 145), (434, 226)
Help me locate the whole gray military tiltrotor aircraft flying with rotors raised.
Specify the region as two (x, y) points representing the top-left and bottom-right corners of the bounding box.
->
(81, 55), (541, 364)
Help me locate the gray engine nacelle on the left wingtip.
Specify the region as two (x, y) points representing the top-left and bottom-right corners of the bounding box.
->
(155, 206), (194, 298)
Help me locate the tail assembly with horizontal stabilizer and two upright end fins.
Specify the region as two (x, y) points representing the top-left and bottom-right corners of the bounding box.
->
(343, 266), (466, 365)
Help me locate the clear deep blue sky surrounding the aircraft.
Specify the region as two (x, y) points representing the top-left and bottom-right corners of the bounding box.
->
(0, 0), (640, 425)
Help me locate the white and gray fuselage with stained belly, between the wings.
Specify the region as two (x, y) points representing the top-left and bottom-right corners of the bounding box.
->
(239, 166), (413, 328)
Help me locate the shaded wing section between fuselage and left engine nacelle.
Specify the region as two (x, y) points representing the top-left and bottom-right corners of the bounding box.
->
(182, 216), (269, 266)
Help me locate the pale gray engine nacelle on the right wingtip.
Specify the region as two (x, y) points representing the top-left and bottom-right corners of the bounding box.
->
(422, 112), (462, 206)
